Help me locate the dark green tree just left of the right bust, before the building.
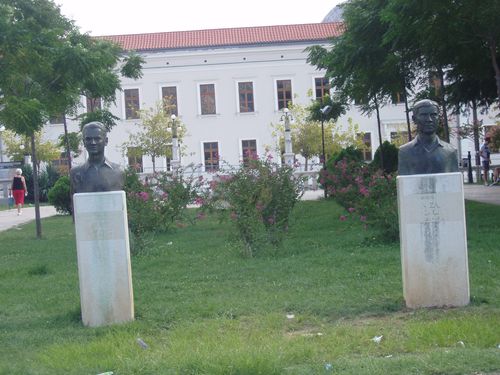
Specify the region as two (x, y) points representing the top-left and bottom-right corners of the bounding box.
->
(308, 0), (412, 171)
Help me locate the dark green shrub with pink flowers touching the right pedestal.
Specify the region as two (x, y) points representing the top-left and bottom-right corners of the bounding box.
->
(320, 154), (399, 241)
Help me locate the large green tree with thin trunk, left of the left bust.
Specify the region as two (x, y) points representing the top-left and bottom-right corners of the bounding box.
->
(0, 0), (142, 238)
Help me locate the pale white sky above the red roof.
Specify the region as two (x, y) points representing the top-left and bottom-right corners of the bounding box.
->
(54, 0), (341, 36)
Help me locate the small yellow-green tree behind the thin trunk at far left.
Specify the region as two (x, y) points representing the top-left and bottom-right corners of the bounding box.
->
(2, 130), (61, 170)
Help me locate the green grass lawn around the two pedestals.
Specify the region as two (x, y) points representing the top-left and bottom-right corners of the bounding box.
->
(0, 201), (500, 375)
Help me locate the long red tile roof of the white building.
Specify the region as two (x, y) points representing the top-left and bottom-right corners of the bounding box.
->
(101, 22), (343, 51)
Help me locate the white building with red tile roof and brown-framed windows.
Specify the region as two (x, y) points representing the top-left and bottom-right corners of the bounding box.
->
(41, 22), (494, 172)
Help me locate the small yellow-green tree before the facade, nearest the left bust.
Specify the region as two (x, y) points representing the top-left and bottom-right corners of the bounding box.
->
(122, 102), (186, 173)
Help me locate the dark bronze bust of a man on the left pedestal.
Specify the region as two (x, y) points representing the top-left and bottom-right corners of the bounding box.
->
(70, 121), (124, 193)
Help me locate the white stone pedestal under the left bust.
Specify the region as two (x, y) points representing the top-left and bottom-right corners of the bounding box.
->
(73, 191), (134, 327)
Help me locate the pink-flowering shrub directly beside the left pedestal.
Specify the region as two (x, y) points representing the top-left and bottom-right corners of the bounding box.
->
(125, 168), (204, 250)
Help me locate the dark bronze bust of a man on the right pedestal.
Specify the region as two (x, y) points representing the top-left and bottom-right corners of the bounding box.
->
(398, 99), (458, 175)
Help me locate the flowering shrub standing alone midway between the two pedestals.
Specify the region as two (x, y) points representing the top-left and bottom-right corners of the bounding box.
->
(203, 157), (302, 256)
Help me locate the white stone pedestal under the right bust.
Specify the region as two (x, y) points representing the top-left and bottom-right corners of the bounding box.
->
(397, 173), (469, 308)
